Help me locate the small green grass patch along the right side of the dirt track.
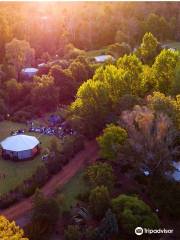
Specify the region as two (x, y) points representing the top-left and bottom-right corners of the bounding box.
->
(58, 170), (87, 211)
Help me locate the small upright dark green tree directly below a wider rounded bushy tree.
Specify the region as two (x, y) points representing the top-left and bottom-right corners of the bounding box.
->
(89, 186), (110, 219)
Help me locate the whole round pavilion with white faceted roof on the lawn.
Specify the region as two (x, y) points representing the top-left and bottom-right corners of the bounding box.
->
(1, 134), (40, 160)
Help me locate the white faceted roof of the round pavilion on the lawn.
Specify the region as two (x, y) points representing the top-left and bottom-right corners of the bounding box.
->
(1, 134), (39, 152)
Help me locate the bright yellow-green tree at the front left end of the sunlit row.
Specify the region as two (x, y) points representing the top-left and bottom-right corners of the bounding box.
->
(71, 80), (111, 137)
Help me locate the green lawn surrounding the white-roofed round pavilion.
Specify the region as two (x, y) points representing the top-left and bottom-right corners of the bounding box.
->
(0, 121), (52, 195)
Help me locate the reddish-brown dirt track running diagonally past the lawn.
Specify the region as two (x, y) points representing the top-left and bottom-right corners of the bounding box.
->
(0, 141), (98, 220)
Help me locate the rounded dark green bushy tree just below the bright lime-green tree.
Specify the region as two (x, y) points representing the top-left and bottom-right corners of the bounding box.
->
(85, 163), (114, 191)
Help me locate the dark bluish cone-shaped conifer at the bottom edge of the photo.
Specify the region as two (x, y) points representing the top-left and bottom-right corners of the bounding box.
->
(96, 209), (119, 240)
